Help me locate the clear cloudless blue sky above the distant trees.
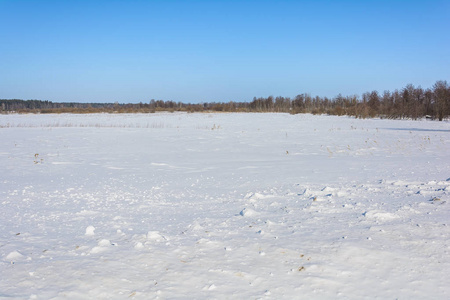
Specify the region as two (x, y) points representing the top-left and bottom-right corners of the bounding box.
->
(0, 0), (450, 103)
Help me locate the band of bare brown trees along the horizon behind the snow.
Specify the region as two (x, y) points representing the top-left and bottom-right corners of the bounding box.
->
(0, 80), (450, 121)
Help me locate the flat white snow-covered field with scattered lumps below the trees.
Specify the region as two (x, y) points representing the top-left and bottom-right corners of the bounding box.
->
(0, 113), (450, 299)
